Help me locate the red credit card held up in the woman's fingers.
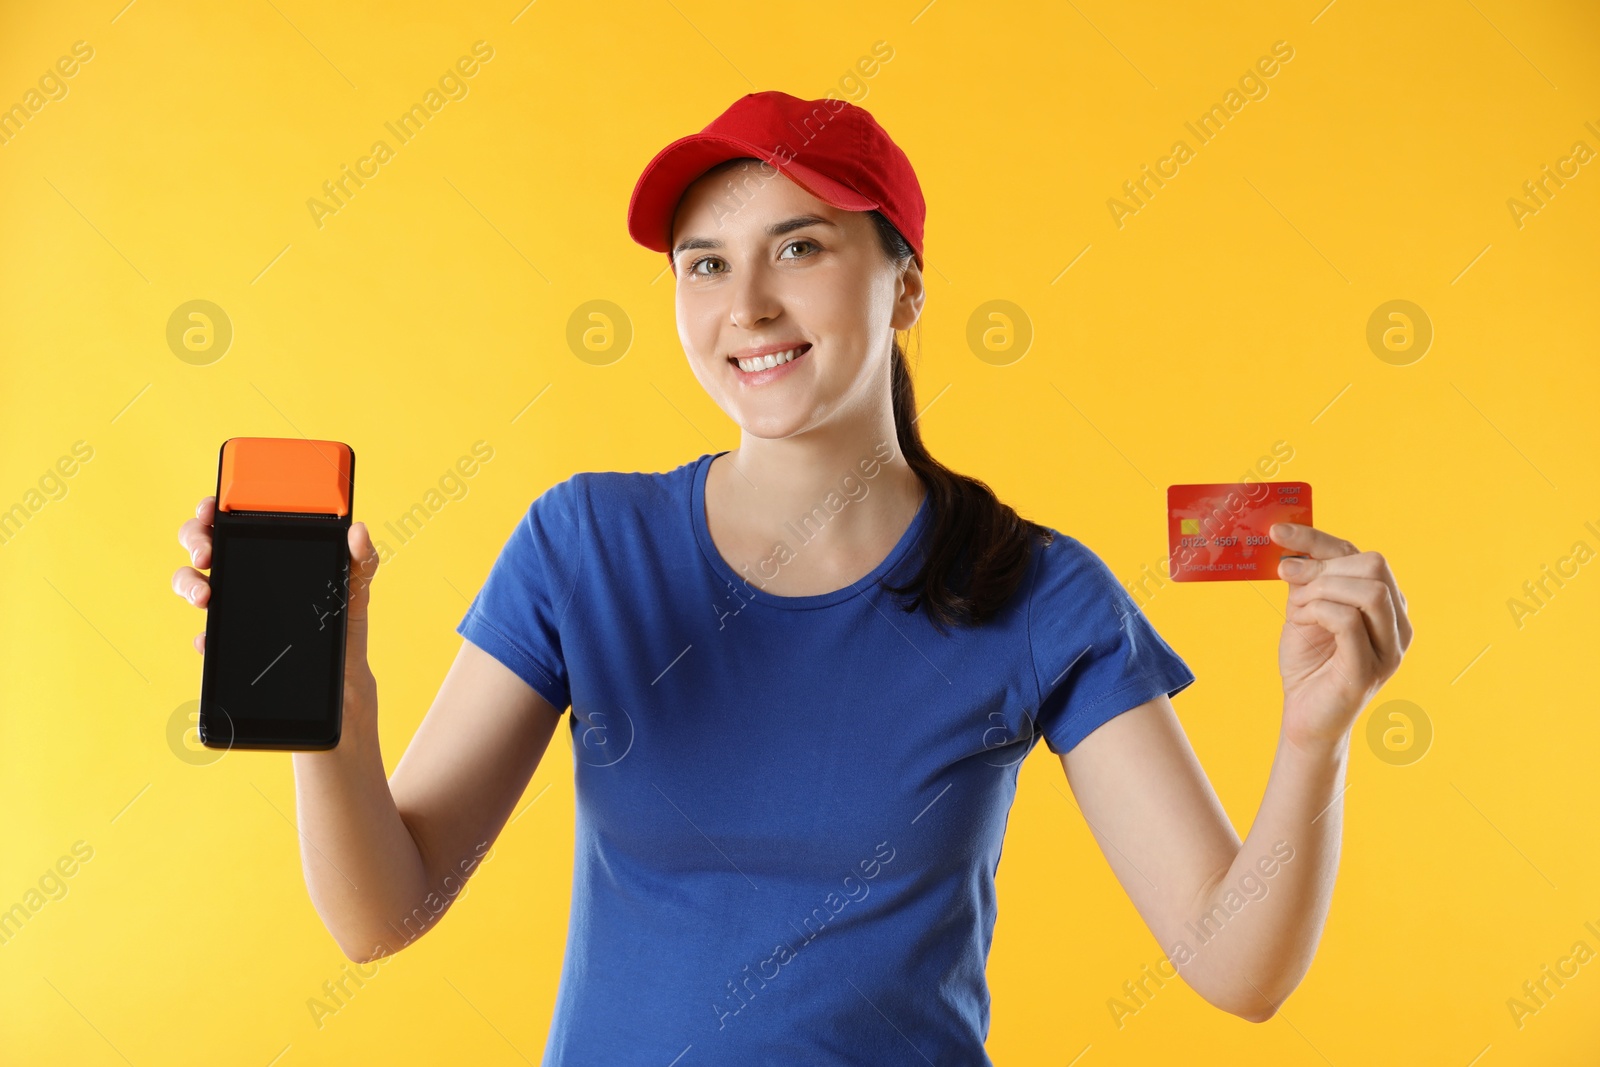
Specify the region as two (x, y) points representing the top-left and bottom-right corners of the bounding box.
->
(1166, 482), (1312, 582)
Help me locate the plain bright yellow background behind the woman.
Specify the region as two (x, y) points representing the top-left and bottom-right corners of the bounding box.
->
(0, 0), (1600, 1067)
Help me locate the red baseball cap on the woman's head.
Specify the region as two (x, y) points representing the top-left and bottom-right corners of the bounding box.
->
(627, 91), (926, 267)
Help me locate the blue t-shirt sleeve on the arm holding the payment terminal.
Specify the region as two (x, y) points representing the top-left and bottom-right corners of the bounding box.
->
(456, 475), (584, 712)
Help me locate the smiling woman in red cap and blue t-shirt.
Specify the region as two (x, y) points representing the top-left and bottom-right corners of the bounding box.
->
(174, 93), (1411, 1065)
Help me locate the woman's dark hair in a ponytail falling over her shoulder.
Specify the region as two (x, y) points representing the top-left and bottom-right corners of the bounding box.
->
(867, 211), (1054, 639)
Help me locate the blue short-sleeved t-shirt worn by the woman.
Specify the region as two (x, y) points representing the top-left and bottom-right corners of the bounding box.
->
(458, 453), (1194, 1067)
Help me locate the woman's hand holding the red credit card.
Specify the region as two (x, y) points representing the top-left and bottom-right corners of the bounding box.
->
(1270, 523), (1411, 750)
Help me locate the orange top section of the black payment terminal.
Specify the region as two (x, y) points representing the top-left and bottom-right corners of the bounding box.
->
(216, 437), (350, 517)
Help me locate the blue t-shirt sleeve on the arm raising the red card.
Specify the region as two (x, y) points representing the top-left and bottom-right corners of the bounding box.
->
(1027, 531), (1195, 753)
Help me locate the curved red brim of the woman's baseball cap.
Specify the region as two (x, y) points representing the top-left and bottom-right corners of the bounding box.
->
(627, 133), (880, 256)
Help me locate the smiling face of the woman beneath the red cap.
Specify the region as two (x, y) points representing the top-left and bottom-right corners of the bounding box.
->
(672, 162), (923, 440)
